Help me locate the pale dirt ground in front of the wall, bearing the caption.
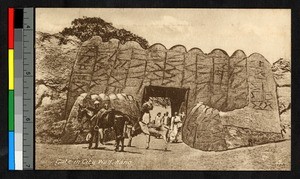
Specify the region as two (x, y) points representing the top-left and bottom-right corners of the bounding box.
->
(36, 135), (291, 170)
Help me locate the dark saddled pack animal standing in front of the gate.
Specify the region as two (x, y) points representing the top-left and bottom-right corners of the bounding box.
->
(78, 105), (131, 152)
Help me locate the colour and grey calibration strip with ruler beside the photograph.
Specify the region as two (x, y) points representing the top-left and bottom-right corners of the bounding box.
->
(8, 8), (34, 170)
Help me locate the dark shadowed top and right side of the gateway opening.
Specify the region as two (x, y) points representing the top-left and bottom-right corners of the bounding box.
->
(142, 86), (189, 114)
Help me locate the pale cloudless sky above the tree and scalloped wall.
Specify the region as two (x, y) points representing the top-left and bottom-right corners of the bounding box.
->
(36, 8), (291, 63)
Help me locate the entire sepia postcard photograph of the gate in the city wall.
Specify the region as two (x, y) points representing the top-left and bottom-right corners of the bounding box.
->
(35, 8), (291, 171)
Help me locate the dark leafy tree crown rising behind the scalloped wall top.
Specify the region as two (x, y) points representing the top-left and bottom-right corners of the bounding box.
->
(60, 17), (149, 48)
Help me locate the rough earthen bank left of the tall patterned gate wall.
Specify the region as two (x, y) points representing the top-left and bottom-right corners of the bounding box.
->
(35, 32), (81, 143)
